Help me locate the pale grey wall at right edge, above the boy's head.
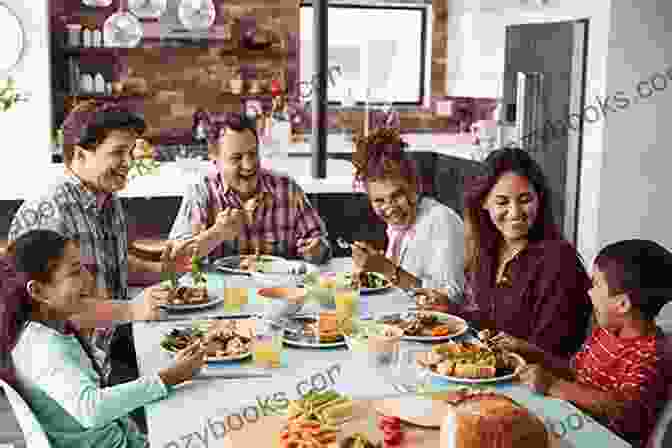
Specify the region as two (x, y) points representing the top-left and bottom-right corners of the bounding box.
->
(598, 0), (672, 252)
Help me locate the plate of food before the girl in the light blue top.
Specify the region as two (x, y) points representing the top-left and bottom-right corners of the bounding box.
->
(160, 320), (252, 362)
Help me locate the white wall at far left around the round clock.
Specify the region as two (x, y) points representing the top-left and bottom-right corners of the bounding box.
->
(0, 0), (51, 196)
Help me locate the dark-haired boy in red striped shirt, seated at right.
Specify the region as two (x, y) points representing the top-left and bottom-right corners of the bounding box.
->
(493, 239), (672, 447)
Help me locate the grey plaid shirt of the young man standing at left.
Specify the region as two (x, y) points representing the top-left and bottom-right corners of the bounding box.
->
(9, 175), (128, 377)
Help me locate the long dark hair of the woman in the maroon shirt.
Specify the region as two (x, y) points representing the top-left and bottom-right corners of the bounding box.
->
(464, 148), (562, 273)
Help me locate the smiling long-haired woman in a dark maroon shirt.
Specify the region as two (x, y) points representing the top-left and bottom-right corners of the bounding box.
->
(420, 148), (590, 359)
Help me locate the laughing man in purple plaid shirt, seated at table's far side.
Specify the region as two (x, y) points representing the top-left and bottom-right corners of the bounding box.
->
(170, 114), (331, 264)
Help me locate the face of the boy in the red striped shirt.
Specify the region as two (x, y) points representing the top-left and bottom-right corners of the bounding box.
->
(588, 267), (631, 329)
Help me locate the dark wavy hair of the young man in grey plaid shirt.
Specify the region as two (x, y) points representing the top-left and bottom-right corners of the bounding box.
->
(63, 100), (147, 165)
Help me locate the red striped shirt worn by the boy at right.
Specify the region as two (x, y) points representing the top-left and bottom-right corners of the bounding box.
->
(574, 327), (664, 443)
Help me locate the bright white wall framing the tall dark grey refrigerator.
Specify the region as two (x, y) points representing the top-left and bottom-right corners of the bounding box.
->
(446, 0), (616, 263)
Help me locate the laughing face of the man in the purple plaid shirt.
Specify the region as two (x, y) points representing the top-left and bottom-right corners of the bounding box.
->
(217, 129), (259, 198)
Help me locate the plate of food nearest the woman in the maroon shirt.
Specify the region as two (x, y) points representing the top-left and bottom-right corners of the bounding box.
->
(376, 311), (469, 342)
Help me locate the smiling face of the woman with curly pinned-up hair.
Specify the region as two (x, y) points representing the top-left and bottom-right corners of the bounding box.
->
(367, 179), (417, 225)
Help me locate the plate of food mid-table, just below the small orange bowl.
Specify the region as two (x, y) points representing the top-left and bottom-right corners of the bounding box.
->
(283, 315), (346, 348)
